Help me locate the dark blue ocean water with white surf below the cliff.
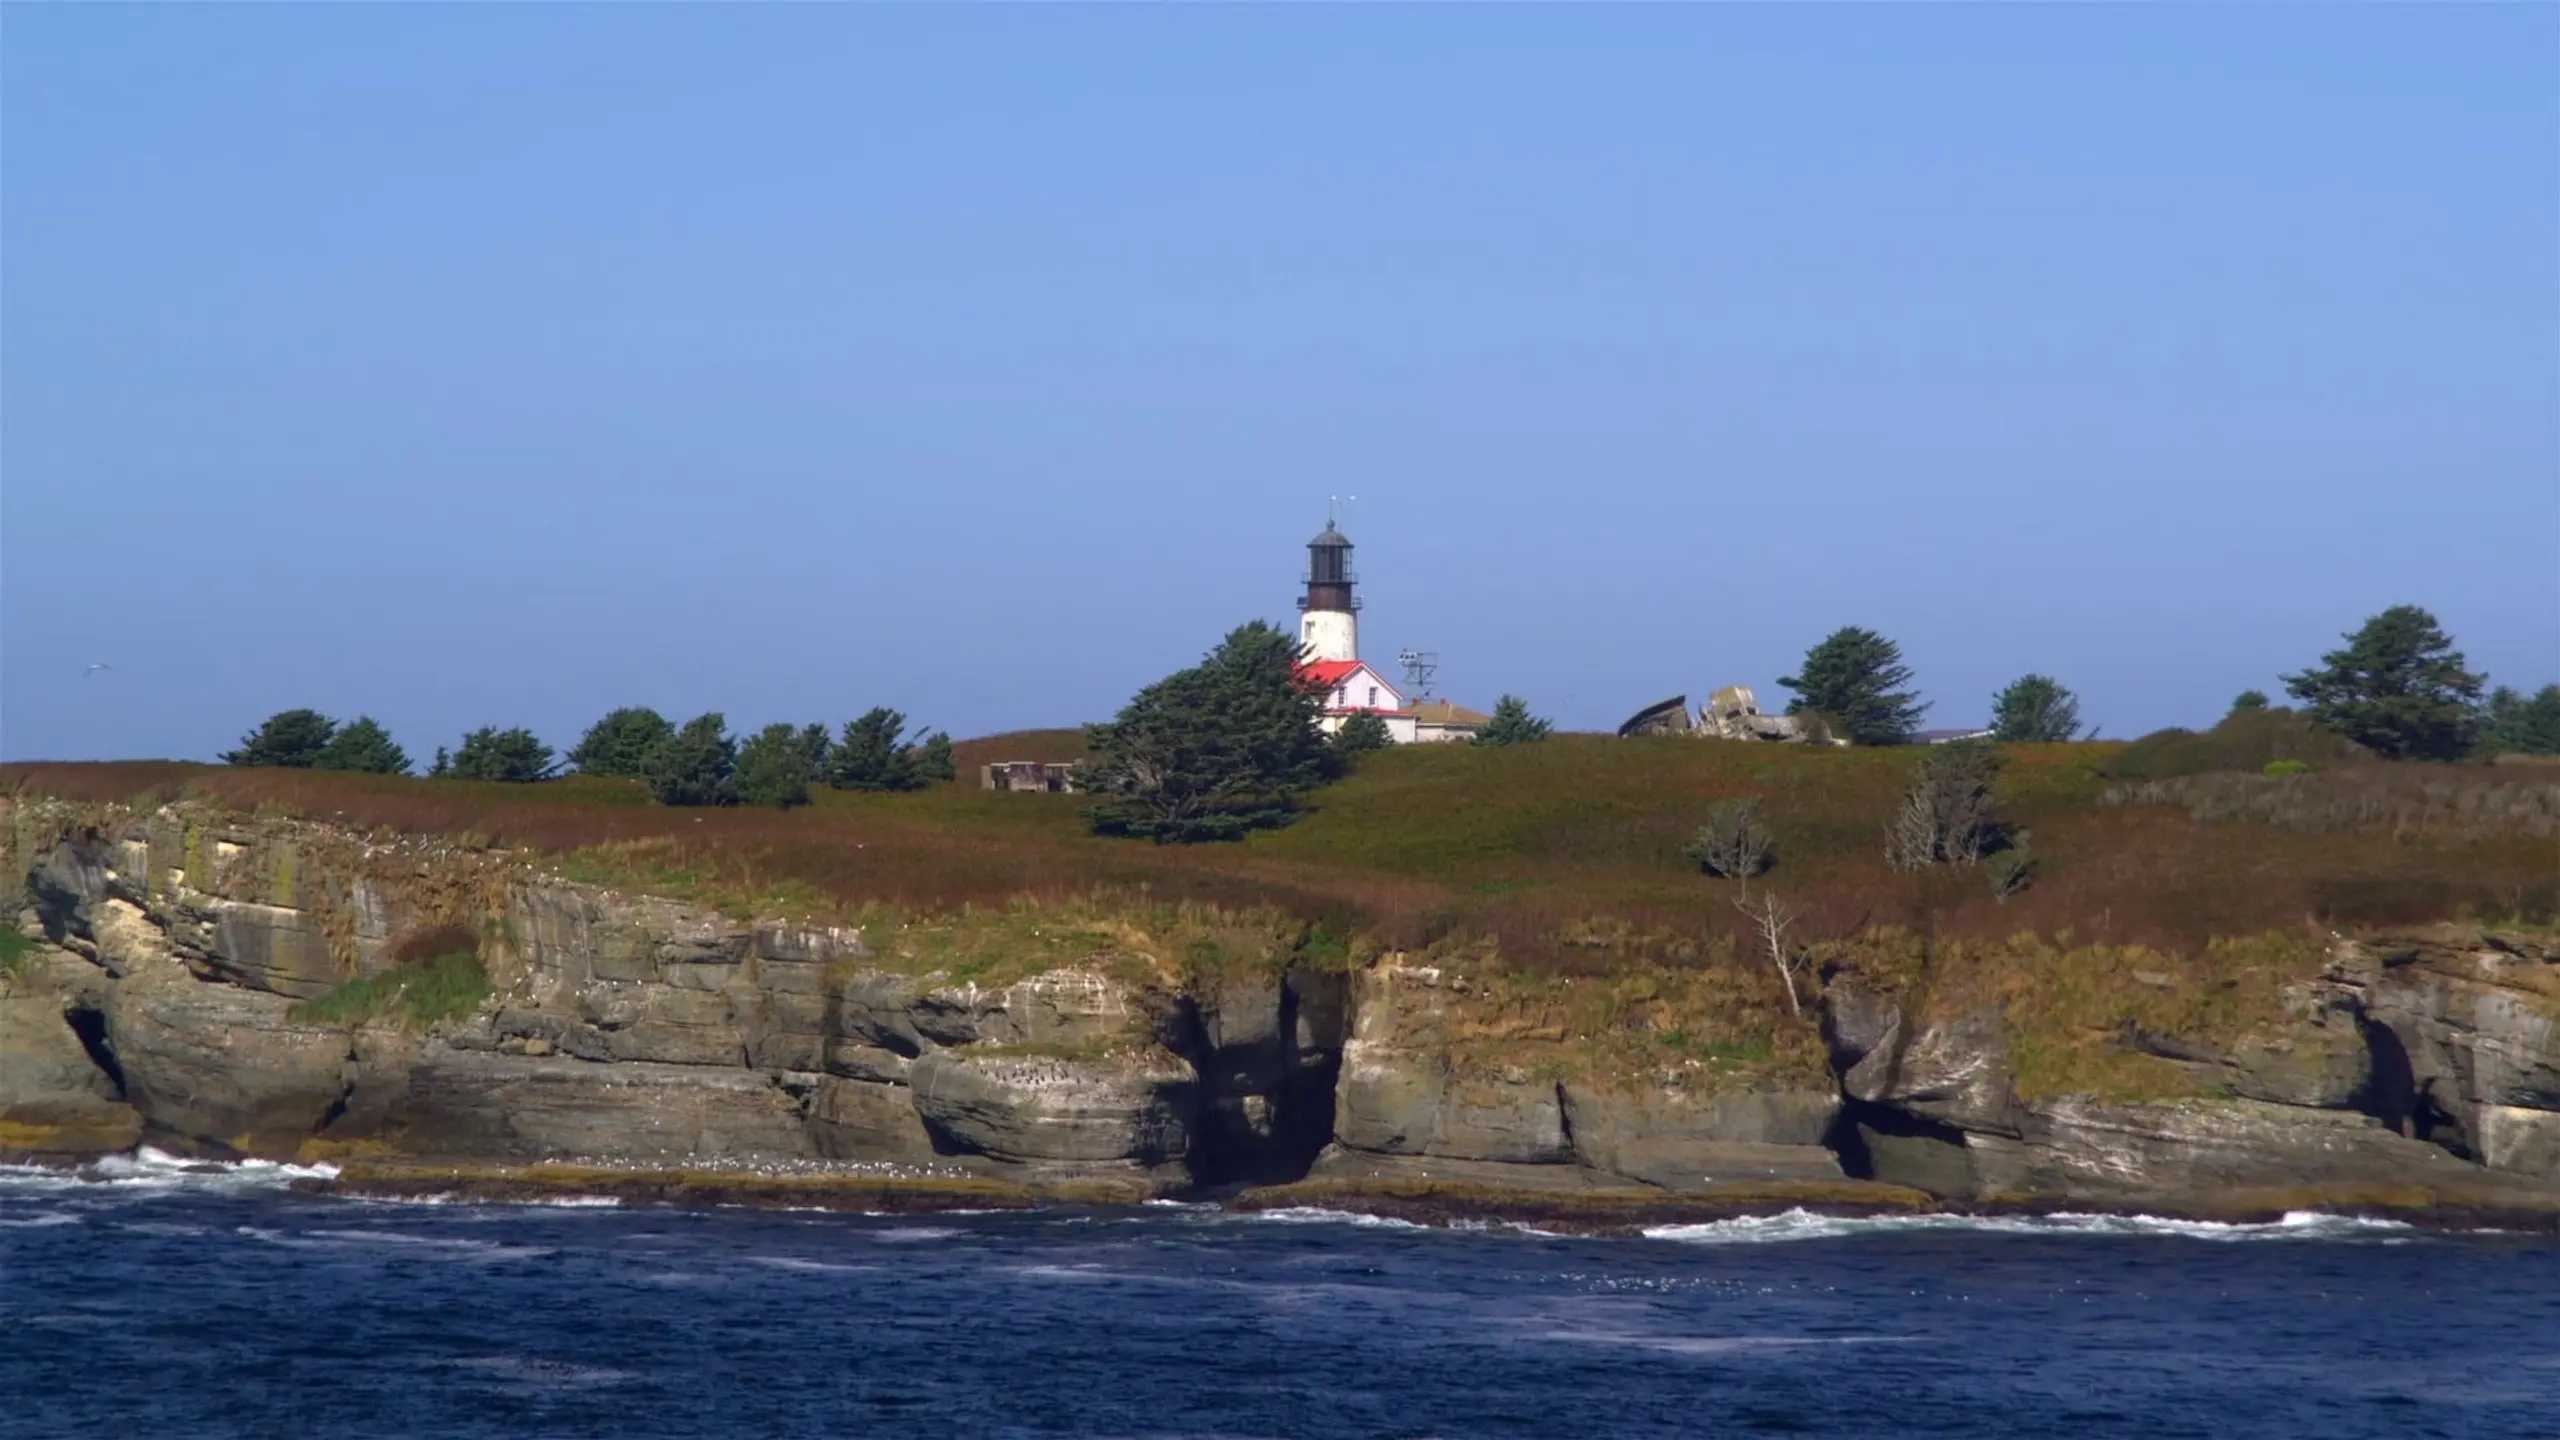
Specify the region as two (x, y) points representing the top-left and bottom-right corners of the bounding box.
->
(0, 1156), (2560, 1440)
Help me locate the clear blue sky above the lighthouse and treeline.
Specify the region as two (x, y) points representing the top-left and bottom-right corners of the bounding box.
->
(0, 5), (2560, 758)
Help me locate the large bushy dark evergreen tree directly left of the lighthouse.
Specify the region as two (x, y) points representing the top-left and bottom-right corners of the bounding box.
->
(1085, 620), (1339, 846)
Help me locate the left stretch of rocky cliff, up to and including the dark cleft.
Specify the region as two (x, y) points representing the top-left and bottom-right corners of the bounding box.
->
(0, 805), (1341, 1184)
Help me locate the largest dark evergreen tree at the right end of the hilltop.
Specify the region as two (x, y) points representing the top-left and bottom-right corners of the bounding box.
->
(2284, 605), (2481, 761)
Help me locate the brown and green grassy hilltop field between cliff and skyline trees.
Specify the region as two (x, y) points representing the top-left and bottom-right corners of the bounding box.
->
(0, 712), (2560, 969)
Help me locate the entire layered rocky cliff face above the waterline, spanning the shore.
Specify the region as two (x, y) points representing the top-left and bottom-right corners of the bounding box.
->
(0, 802), (2560, 1207)
